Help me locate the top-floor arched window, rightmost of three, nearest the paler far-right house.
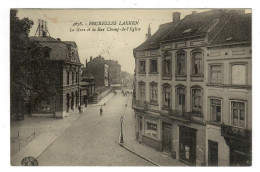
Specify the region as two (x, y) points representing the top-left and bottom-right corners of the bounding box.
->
(192, 52), (203, 75)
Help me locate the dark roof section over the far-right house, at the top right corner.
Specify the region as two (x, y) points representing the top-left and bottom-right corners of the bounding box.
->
(210, 14), (252, 44)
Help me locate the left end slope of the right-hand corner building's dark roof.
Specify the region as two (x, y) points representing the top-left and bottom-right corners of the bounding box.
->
(136, 22), (175, 50)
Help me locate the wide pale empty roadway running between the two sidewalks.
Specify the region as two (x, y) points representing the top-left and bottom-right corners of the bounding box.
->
(37, 92), (153, 166)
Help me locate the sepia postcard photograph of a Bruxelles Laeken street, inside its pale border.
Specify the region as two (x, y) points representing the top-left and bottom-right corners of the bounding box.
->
(9, 6), (252, 167)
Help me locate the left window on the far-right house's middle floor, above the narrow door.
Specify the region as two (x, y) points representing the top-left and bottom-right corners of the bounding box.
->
(210, 99), (221, 123)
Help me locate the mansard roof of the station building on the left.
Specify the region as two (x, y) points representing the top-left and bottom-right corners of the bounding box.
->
(30, 36), (80, 63)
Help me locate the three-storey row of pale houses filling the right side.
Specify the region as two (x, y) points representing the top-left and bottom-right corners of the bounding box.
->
(132, 9), (252, 166)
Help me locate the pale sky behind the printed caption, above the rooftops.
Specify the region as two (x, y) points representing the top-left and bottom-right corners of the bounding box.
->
(18, 9), (250, 74)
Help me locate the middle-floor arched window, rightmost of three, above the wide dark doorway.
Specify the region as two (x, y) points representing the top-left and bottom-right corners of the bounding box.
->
(192, 88), (202, 114)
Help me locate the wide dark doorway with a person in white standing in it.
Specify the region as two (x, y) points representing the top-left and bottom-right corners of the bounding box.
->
(179, 126), (196, 165)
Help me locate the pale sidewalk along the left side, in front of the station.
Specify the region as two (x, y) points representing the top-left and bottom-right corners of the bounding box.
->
(11, 93), (114, 166)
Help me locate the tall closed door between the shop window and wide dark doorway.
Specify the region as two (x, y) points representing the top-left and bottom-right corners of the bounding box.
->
(162, 123), (172, 153)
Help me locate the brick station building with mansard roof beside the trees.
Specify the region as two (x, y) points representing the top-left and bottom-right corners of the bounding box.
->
(30, 34), (81, 118)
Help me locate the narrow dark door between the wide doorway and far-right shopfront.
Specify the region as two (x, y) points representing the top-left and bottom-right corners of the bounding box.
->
(208, 140), (218, 166)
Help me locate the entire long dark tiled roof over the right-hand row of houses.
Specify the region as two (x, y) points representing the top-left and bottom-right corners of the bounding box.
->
(136, 9), (252, 50)
